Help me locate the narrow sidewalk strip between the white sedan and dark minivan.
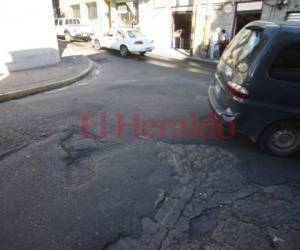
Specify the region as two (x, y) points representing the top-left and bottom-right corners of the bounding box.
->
(147, 48), (219, 65)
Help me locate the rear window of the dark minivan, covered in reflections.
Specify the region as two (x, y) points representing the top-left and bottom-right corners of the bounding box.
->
(222, 28), (265, 72)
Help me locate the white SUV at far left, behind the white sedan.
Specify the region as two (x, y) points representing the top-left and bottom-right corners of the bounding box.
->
(55, 18), (93, 42)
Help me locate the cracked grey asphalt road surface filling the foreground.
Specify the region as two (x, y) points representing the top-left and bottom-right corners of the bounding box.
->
(0, 43), (300, 250)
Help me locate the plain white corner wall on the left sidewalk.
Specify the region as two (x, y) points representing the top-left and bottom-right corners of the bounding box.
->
(0, 0), (60, 72)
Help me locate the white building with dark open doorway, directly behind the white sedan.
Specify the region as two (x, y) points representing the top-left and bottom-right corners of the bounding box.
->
(111, 0), (194, 49)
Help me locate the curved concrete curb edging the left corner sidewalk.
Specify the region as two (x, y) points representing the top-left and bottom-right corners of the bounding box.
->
(0, 57), (94, 102)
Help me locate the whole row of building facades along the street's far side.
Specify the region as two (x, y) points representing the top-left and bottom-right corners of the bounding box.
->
(56, 0), (300, 52)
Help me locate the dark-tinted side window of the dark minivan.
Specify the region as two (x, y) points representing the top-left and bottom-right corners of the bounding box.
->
(270, 44), (300, 84)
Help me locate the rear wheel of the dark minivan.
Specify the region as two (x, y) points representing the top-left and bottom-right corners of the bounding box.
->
(259, 122), (300, 157)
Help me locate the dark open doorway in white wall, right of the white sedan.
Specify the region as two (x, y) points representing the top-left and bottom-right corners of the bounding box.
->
(173, 11), (192, 50)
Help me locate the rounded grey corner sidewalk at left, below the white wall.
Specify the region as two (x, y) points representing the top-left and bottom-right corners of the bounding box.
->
(0, 56), (93, 102)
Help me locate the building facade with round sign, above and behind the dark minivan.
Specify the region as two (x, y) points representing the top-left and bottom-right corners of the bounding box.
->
(194, 0), (300, 57)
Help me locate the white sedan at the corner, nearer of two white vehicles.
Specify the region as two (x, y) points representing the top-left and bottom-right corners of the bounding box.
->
(92, 28), (154, 57)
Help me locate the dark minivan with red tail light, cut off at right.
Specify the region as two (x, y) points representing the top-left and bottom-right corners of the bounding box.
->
(208, 21), (300, 156)
